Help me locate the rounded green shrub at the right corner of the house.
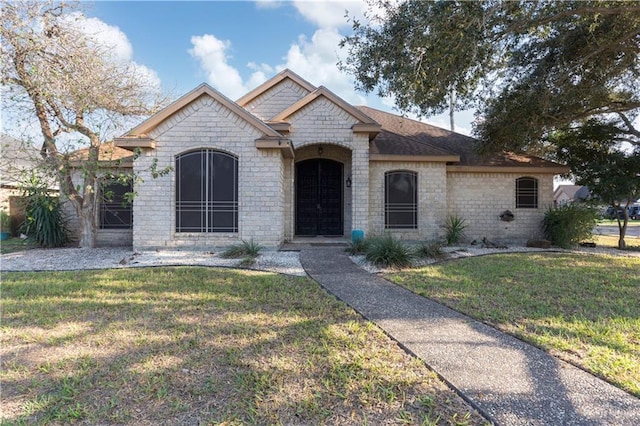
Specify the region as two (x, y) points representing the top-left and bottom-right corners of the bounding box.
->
(542, 203), (598, 248)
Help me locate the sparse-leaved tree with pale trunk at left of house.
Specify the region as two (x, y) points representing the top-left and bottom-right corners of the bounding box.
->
(0, 1), (166, 247)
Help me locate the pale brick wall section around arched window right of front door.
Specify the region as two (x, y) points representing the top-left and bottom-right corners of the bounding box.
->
(369, 161), (447, 240)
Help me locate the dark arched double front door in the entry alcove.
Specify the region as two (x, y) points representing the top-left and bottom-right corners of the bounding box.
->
(296, 159), (342, 236)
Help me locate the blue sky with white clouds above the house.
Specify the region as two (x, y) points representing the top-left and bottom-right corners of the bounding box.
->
(82, 0), (473, 134)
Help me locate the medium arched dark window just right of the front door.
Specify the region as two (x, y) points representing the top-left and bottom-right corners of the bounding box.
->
(384, 171), (418, 229)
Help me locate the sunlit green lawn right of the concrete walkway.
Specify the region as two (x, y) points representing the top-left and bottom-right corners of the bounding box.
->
(387, 253), (640, 396)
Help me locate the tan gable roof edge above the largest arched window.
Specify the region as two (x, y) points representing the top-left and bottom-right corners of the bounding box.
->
(116, 83), (282, 141)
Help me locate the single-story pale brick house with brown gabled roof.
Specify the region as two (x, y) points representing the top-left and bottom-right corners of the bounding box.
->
(102, 70), (568, 249)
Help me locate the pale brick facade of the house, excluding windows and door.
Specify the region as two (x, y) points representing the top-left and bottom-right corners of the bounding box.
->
(105, 71), (564, 249)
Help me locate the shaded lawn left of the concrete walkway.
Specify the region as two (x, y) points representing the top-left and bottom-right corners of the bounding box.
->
(0, 268), (484, 425)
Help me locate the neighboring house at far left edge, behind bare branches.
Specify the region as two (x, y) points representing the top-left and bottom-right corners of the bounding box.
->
(0, 133), (58, 231)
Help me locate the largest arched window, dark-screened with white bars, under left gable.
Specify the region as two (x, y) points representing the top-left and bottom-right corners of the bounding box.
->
(176, 149), (238, 232)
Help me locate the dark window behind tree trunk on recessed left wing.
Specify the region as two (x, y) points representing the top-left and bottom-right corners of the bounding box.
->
(100, 181), (133, 229)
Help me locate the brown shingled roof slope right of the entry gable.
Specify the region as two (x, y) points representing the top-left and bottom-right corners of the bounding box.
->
(358, 106), (568, 173)
